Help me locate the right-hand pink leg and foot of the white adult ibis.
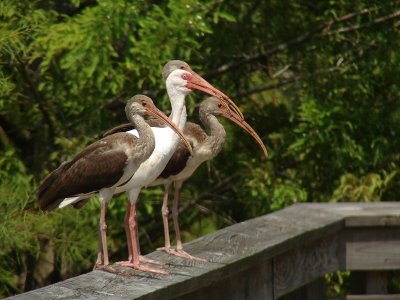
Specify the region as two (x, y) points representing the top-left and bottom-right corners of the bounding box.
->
(117, 204), (168, 275)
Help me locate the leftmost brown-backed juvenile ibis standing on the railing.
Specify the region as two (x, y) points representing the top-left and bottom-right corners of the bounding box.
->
(37, 95), (191, 272)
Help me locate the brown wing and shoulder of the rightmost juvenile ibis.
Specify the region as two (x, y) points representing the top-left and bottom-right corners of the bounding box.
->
(158, 122), (207, 178)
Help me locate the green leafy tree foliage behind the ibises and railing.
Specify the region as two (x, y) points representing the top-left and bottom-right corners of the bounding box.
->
(0, 0), (400, 297)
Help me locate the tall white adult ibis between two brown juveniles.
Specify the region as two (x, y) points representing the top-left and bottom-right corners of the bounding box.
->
(109, 60), (240, 274)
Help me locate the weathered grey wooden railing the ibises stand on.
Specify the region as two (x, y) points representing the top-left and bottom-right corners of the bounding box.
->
(7, 202), (400, 300)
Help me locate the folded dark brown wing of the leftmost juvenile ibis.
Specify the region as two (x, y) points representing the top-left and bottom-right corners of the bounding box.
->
(37, 133), (136, 210)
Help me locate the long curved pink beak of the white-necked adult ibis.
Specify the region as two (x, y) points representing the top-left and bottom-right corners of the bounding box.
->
(186, 69), (244, 120)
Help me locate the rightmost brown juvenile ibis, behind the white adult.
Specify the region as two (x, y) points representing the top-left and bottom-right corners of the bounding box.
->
(151, 97), (268, 261)
